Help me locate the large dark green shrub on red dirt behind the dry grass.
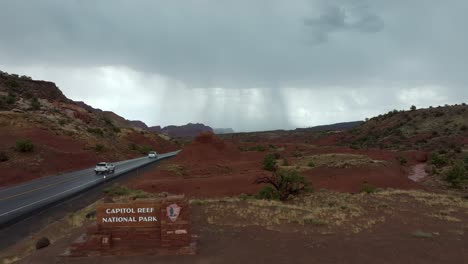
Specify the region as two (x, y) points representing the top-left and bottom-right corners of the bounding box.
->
(255, 170), (312, 201)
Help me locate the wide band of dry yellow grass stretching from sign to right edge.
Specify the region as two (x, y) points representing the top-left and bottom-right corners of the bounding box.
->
(191, 190), (468, 233)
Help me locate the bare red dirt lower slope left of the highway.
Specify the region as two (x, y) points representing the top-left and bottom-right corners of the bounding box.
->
(0, 127), (177, 186)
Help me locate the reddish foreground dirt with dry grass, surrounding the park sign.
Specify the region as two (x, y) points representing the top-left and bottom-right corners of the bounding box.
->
(6, 190), (468, 263)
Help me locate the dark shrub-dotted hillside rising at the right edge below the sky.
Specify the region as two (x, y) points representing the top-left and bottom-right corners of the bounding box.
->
(344, 104), (468, 151)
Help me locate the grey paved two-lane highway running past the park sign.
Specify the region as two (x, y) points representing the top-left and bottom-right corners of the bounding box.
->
(0, 151), (179, 226)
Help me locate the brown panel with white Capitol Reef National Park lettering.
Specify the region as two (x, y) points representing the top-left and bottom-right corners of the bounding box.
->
(96, 201), (161, 228)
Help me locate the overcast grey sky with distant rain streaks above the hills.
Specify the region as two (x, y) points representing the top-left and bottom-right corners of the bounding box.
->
(0, 0), (468, 131)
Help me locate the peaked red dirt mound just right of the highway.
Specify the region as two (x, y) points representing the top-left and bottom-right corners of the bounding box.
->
(129, 134), (267, 197)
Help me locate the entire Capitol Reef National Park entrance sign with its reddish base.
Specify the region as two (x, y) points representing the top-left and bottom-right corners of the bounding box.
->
(69, 195), (195, 256)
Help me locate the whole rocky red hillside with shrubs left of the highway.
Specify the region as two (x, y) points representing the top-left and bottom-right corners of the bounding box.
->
(0, 72), (178, 186)
